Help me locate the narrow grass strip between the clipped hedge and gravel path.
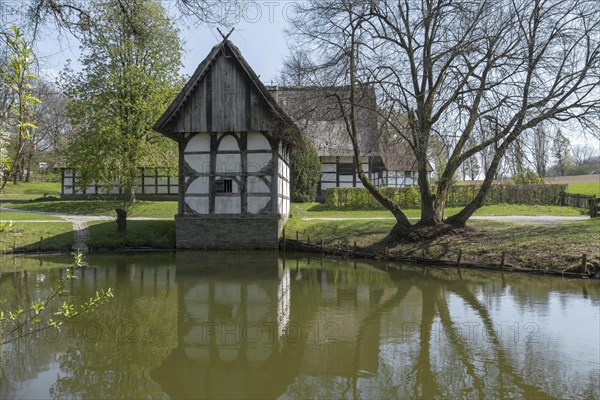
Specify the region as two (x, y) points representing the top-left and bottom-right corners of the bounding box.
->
(290, 203), (586, 218)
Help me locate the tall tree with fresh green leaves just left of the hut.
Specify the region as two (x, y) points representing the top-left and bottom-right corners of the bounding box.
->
(64, 0), (182, 231)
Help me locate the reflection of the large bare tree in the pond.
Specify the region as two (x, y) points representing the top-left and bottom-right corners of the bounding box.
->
(350, 268), (598, 398)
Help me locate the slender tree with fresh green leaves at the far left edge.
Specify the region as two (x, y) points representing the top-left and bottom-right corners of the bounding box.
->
(0, 25), (40, 191)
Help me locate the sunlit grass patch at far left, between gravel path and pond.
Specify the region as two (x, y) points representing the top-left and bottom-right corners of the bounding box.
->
(0, 221), (73, 251)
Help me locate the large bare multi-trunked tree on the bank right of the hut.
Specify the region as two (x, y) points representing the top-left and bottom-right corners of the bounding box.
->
(286, 0), (600, 236)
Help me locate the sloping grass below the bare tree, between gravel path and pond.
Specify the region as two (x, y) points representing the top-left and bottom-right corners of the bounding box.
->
(286, 218), (600, 270)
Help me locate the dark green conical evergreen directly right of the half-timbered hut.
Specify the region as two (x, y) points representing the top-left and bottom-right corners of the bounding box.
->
(290, 137), (321, 202)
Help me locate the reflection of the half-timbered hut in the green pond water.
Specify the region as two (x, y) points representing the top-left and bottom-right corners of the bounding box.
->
(152, 252), (293, 398)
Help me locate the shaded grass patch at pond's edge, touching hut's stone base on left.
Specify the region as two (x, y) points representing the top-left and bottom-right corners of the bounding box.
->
(86, 221), (175, 249)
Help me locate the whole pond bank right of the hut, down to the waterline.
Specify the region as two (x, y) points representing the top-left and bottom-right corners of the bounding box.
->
(281, 219), (600, 277)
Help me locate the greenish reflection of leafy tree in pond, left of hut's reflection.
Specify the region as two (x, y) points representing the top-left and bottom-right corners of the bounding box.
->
(51, 262), (177, 399)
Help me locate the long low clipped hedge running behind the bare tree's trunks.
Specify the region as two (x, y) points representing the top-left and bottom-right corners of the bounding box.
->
(325, 184), (567, 209)
